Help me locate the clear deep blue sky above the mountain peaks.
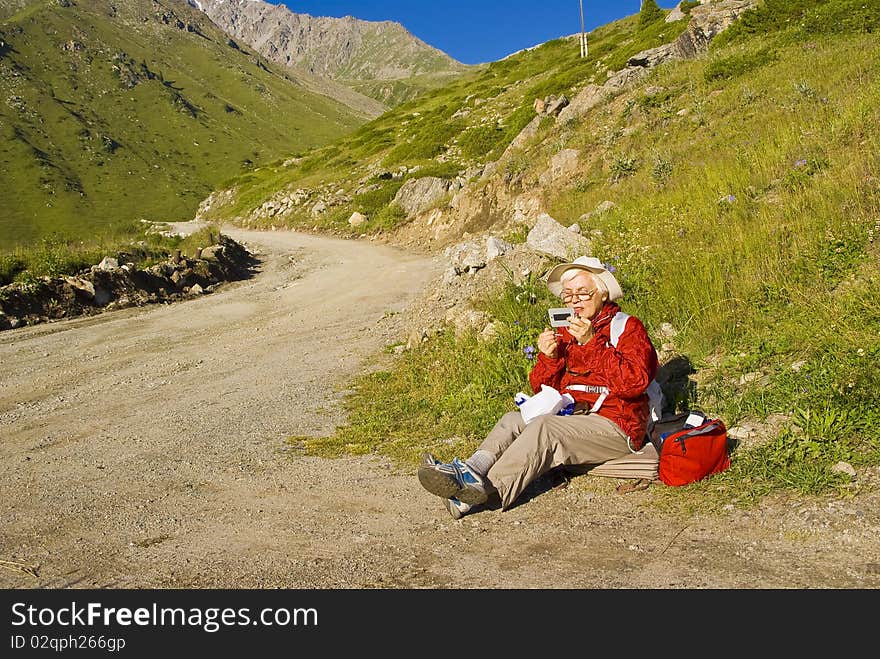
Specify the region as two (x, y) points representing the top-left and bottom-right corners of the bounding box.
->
(282, 0), (678, 64)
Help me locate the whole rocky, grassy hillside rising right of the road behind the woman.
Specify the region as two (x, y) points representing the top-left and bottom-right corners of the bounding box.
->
(199, 0), (880, 502)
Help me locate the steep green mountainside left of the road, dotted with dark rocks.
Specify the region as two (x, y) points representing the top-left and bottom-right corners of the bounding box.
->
(0, 0), (363, 249)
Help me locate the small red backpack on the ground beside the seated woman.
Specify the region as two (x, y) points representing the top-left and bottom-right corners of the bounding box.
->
(651, 413), (730, 485)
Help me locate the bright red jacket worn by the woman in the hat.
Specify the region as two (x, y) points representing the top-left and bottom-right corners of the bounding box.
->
(529, 302), (657, 450)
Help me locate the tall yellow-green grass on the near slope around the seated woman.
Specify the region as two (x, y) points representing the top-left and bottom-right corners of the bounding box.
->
(294, 0), (880, 508)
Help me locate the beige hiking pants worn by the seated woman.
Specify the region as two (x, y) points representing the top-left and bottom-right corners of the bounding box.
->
(477, 411), (630, 510)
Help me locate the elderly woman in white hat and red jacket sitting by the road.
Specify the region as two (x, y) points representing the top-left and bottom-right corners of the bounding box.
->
(418, 256), (657, 519)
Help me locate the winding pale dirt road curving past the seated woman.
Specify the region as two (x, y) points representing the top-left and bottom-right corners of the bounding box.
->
(0, 231), (880, 588)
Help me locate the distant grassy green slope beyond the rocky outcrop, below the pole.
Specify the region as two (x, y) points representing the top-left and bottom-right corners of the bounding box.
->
(203, 8), (687, 234)
